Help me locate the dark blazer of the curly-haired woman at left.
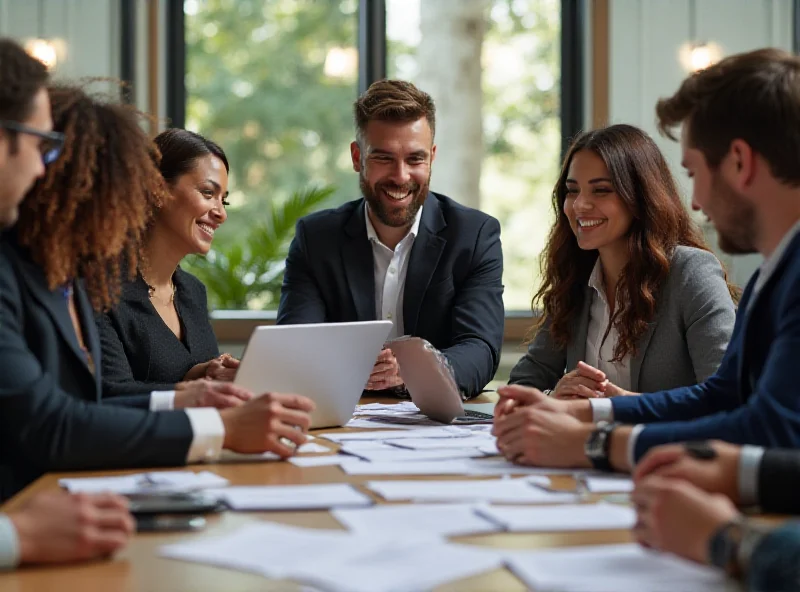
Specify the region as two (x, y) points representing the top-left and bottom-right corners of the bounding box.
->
(0, 233), (192, 500)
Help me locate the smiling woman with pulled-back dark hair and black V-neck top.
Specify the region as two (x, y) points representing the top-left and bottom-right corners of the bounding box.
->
(97, 128), (239, 397)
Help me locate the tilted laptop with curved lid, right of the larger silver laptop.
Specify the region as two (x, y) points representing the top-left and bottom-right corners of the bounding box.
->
(386, 336), (494, 424)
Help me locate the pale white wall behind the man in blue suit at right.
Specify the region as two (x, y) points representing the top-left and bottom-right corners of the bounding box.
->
(609, 0), (792, 285)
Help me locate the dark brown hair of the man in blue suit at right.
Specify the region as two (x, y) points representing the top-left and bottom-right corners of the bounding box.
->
(656, 48), (800, 185)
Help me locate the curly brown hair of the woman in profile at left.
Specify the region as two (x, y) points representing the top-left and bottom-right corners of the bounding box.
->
(17, 86), (168, 311)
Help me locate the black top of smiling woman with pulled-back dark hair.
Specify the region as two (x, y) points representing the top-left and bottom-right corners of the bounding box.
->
(97, 268), (219, 397)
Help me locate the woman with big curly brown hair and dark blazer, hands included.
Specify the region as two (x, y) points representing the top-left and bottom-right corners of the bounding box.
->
(0, 82), (313, 501)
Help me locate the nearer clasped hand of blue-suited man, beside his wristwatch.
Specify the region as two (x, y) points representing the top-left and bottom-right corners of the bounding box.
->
(492, 400), (593, 467)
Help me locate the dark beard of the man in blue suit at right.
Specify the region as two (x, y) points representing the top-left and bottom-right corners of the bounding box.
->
(711, 174), (757, 255)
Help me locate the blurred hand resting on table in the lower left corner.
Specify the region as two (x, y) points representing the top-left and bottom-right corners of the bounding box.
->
(9, 492), (136, 563)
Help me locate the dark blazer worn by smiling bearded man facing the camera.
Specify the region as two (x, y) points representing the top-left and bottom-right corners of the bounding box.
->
(278, 193), (504, 396)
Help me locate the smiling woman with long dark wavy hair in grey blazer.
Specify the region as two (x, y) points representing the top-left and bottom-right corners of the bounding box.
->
(510, 125), (736, 398)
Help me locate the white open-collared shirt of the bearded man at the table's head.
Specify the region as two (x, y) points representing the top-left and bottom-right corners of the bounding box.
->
(364, 204), (422, 340)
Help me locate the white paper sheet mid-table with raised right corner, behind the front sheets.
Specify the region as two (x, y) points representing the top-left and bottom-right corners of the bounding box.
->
(366, 476), (579, 504)
